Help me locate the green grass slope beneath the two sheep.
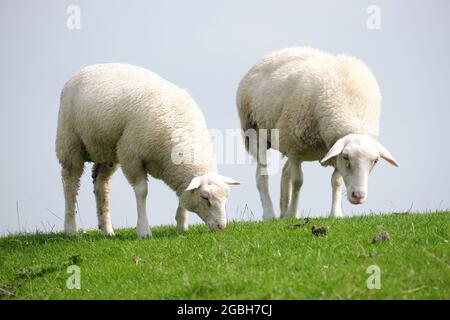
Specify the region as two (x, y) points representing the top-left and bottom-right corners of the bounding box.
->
(0, 212), (450, 299)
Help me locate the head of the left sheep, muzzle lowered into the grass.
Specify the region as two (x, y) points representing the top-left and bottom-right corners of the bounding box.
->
(180, 173), (240, 230)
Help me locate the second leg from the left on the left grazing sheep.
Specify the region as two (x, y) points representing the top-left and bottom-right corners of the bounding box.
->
(92, 163), (118, 236)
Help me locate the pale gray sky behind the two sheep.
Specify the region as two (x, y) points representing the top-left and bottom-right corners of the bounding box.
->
(0, 0), (450, 234)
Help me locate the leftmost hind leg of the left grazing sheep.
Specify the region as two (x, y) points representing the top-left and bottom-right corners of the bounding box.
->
(61, 163), (84, 235)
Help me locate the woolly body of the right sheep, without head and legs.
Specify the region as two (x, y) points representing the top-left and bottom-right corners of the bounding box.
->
(237, 48), (381, 160)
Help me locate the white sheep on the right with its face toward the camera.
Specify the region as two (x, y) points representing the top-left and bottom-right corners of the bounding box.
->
(237, 47), (399, 219)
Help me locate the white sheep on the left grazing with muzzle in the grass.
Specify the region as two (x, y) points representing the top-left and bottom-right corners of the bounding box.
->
(56, 63), (239, 237)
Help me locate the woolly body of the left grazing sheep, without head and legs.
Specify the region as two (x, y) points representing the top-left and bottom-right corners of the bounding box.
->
(56, 63), (217, 194)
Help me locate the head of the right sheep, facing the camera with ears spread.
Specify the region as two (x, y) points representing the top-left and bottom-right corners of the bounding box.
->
(321, 134), (399, 204)
